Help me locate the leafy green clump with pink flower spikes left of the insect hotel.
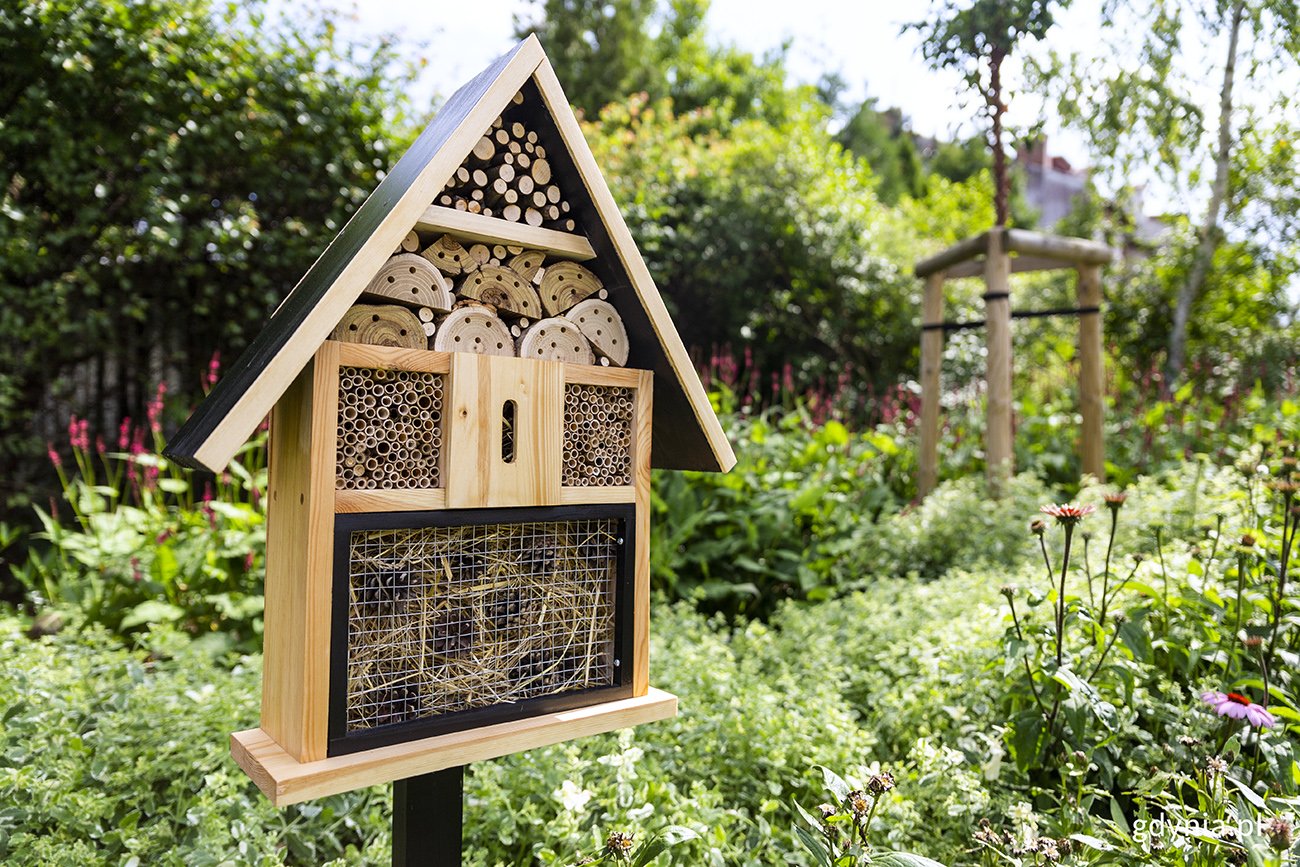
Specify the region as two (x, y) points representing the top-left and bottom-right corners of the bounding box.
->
(14, 413), (267, 650)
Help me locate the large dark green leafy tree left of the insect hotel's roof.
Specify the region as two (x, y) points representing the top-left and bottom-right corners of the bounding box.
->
(0, 0), (400, 507)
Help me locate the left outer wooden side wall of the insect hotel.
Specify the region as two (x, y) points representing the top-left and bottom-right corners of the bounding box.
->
(261, 343), (338, 762)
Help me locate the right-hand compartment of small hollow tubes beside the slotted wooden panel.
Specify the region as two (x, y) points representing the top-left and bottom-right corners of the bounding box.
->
(560, 383), (634, 486)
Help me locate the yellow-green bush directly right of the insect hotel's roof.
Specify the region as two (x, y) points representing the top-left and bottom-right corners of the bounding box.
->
(585, 100), (917, 400)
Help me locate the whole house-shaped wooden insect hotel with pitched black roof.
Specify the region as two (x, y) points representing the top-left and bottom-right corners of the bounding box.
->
(168, 38), (735, 805)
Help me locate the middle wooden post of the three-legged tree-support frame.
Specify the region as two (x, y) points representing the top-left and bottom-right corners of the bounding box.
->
(984, 229), (1014, 495)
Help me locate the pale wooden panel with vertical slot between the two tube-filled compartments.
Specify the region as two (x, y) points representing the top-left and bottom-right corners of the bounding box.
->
(443, 352), (564, 508)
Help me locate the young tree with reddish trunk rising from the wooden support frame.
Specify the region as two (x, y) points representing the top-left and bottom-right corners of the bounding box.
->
(907, 0), (1069, 226)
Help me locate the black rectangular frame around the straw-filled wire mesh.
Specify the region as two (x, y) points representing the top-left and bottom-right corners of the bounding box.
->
(326, 503), (636, 755)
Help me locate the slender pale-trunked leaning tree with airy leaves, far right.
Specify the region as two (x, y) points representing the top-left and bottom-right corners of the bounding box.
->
(1036, 0), (1300, 393)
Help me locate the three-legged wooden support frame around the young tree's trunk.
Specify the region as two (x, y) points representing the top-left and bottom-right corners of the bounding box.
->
(915, 227), (1114, 497)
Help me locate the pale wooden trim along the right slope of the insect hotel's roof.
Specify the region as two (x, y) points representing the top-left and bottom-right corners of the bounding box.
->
(533, 57), (736, 473)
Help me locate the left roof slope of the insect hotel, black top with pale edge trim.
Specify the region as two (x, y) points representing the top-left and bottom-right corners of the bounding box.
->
(164, 35), (545, 472)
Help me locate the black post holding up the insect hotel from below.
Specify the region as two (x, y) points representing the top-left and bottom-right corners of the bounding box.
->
(393, 767), (465, 867)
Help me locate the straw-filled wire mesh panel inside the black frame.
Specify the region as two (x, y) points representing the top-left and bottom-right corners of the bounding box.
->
(335, 516), (625, 734)
